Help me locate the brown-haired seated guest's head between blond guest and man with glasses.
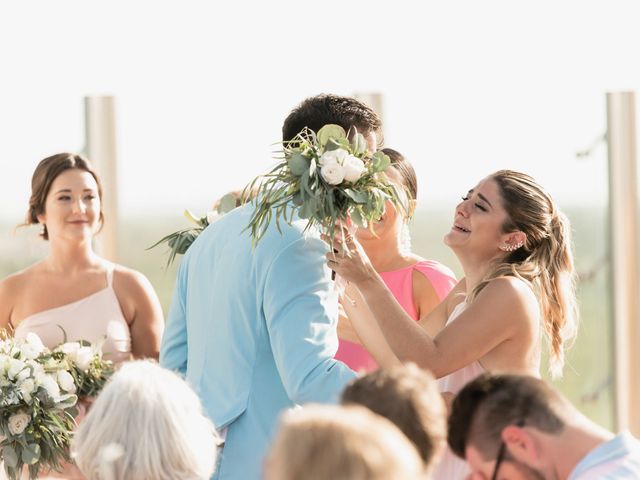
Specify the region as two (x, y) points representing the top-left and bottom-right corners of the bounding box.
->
(342, 364), (447, 470)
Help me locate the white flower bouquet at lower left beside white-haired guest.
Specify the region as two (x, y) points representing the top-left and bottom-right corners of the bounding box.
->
(0, 333), (78, 480)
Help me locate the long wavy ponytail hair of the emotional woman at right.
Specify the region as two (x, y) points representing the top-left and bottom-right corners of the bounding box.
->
(469, 170), (578, 377)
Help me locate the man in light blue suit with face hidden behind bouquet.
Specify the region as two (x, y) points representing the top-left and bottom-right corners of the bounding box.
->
(160, 95), (381, 480)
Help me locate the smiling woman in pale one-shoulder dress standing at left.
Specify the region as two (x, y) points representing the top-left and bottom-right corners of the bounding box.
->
(0, 153), (164, 478)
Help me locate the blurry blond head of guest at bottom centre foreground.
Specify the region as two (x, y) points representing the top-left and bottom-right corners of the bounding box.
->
(264, 405), (425, 480)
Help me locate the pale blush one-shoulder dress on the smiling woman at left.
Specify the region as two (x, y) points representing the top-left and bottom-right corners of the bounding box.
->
(13, 264), (131, 363)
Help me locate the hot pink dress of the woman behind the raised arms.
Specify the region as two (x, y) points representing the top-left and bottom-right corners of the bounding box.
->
(335, 260), (457, 372)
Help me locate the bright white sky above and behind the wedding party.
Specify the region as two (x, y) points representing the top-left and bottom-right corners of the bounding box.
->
(0, 0), (640, 222)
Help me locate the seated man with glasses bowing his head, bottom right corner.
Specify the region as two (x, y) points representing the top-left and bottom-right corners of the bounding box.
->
(448, 374), (640, 480)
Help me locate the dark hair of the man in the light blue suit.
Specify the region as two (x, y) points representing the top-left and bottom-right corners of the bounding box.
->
(282, 94), (382, 142)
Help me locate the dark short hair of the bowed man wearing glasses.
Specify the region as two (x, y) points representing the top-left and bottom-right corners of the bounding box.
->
(447, 373), (572, 460)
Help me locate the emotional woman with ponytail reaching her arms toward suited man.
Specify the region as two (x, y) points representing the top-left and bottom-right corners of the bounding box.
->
(327, 170), (577, 480)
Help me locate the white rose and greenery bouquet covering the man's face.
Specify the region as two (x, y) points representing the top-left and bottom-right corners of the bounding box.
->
(247, 125), (405, 248)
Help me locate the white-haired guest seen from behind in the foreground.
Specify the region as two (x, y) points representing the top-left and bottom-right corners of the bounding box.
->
(73, 361), (220, 480)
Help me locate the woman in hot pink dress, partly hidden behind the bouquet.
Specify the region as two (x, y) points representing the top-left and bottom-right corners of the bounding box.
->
(335, 148), (457, 372)
